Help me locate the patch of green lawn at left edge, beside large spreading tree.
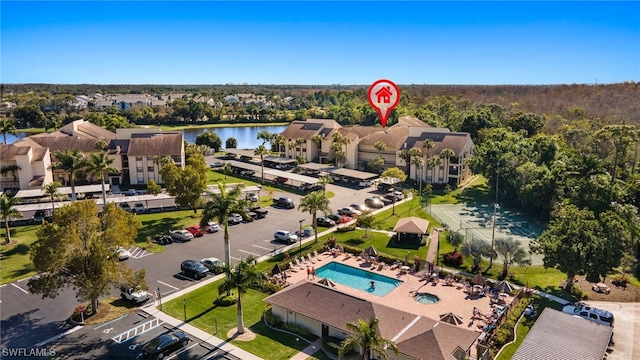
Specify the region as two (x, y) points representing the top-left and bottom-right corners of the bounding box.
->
(0, 225), (39, 284)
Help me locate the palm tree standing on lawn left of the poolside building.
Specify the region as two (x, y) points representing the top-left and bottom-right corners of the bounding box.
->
(218, 256), (266, 334)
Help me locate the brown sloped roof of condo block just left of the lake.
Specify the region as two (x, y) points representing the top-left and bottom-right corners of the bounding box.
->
(127, 131), (183, 156)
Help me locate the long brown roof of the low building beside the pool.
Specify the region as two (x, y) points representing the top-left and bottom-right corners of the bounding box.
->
(265, 280), (480, 359)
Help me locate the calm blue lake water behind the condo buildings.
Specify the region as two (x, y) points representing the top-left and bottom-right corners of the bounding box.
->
(0, 125), (287, 149)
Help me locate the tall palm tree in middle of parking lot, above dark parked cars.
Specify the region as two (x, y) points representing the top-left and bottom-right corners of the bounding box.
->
(200, 181), (247, 288)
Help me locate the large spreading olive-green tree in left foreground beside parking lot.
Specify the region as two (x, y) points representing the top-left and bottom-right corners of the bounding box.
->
(28, 200), (140, 314)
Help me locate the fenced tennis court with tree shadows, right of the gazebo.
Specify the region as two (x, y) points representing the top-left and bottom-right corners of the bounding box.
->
(431, 204), (543, 265)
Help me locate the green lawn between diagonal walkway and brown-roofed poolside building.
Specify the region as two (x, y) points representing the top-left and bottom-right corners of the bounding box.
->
(162, 280), (309, 360)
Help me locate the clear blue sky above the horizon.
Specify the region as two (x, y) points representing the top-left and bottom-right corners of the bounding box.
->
(0, 0), (640, 85)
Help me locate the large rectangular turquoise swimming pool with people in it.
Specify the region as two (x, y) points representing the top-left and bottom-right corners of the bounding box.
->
(316, 262), (402, 296)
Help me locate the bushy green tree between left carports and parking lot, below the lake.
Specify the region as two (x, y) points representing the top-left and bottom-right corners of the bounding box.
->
(160, 153), (207, 214)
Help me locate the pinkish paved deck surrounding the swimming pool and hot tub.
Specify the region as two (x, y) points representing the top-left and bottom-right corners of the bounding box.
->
(287, 252), (512, 331)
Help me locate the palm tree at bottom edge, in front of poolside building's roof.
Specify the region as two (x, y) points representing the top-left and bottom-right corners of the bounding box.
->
(338, 317), (398, 360)
